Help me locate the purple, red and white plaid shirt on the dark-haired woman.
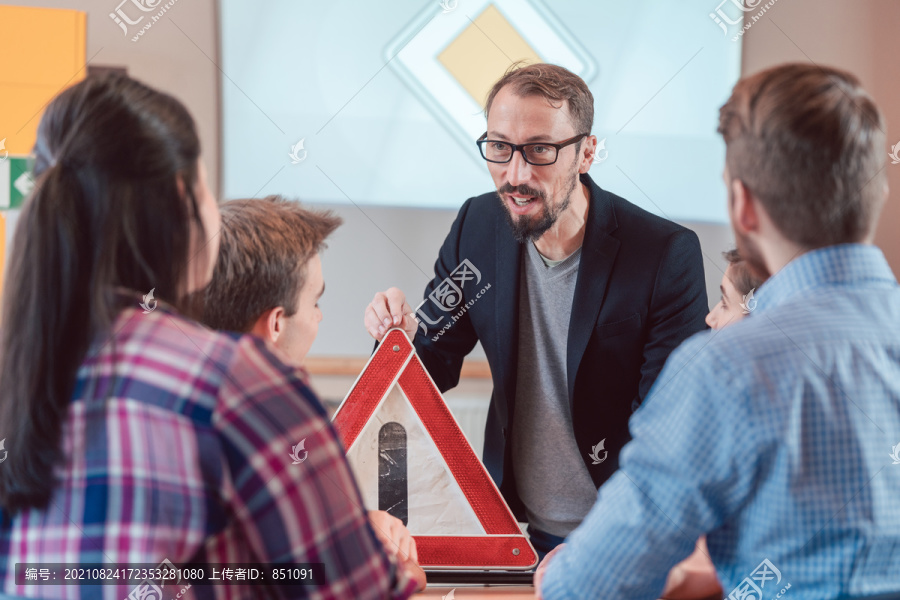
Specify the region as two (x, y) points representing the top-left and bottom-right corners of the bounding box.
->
(0, 303), (415, 600)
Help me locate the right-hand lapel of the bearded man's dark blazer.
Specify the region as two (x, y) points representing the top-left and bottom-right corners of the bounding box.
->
(566, 174), (619, 407)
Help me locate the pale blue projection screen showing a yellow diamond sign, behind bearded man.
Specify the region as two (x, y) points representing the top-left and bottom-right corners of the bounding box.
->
(220, 0), (740, 222)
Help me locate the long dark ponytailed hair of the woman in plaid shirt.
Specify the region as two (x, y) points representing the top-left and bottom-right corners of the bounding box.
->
(0, 75), (206, 514)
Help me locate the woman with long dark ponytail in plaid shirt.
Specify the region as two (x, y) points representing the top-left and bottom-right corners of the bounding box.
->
(0, 75), (424, 599)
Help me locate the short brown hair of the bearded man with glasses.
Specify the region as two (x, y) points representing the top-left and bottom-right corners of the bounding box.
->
(484, 63), (594, 134)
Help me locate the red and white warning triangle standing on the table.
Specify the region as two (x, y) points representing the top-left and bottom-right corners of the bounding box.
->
(333, 329), (537, 569)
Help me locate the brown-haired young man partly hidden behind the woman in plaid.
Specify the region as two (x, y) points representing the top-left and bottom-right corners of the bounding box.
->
(201, 196), (418, 560)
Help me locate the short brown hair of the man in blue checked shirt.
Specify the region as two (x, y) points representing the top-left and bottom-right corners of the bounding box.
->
(719, 63), (886, 249)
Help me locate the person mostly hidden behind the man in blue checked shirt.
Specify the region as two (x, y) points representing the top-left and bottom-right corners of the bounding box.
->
(663, 250), (763, 600)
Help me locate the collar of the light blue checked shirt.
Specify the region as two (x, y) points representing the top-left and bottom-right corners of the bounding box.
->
(754, 244), (897, 312)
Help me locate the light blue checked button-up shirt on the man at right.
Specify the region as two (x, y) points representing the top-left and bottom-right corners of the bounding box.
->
(542, 244), (900, 600)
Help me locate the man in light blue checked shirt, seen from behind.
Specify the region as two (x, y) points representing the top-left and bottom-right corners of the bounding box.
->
(535, 64), (900, 600)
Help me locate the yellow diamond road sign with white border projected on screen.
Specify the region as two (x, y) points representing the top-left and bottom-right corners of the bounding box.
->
(386, 0), (597, 159)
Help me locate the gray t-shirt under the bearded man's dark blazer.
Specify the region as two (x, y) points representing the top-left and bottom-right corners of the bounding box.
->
(512, 243), (597, 537)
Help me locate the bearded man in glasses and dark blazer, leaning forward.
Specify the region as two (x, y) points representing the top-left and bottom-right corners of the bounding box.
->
(365, 64), (708, 555)
